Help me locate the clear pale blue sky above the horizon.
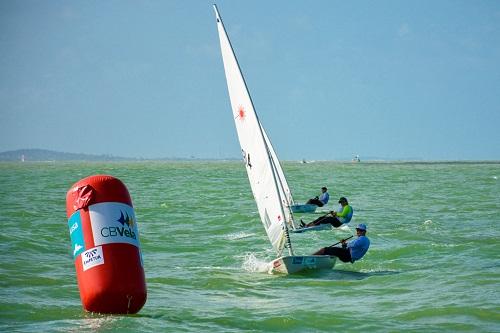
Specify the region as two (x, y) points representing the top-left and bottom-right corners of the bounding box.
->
(0, 0), (500, 160)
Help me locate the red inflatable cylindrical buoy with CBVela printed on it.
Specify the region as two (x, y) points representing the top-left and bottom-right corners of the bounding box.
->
(66, 175), (147, 314)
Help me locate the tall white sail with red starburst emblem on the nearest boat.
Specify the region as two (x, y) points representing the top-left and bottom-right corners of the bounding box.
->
(214, 5), (292, 255)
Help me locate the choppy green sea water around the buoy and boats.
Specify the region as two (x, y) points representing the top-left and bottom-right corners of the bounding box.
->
(0, 161), (500, 333)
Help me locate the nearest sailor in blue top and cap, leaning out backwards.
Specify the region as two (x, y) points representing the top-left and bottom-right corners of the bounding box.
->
(314, 223), (370, 263)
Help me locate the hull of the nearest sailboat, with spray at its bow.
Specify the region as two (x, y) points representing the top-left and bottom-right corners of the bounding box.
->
(269, 255), (336, 274)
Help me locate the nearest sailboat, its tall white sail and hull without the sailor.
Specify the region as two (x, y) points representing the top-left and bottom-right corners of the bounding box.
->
(214, 5), (335, 274)
